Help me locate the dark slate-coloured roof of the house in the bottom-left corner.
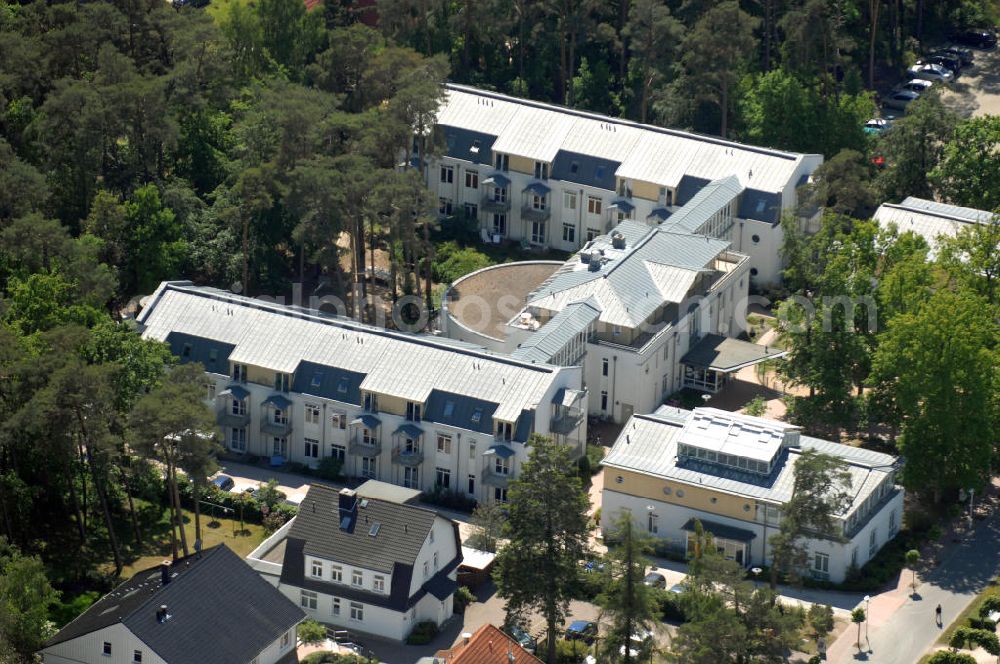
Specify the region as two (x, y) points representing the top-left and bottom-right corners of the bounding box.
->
(46, 544), (305, 664)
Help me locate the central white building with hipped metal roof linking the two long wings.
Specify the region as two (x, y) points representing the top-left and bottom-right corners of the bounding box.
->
(441, 219), (785, 422)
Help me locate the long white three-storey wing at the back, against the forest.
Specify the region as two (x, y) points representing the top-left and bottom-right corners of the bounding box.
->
(427, 85), (823, 285)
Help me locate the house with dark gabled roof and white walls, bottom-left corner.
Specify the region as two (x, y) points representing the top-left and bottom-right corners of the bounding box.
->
(41, 544), (305, 664)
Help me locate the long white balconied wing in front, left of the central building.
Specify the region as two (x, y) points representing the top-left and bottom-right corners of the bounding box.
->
(137, 282), (587, 502)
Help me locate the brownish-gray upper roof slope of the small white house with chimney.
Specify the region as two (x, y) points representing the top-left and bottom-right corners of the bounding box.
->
(288, 484), (437, 573)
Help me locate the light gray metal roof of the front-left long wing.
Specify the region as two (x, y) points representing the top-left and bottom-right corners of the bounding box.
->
(138, 282), (563, 422)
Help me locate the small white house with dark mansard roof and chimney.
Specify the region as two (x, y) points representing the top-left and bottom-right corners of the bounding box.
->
(247, 481), (462, 641)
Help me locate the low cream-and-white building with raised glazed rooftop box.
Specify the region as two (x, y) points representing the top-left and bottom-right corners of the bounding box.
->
(601, 406), (903, 582)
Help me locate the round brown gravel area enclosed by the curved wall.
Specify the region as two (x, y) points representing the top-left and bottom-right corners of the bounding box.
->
(448, 262), (562, 339)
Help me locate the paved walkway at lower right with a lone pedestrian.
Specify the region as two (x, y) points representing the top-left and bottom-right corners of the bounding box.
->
(827, 490), (1000, 664)
